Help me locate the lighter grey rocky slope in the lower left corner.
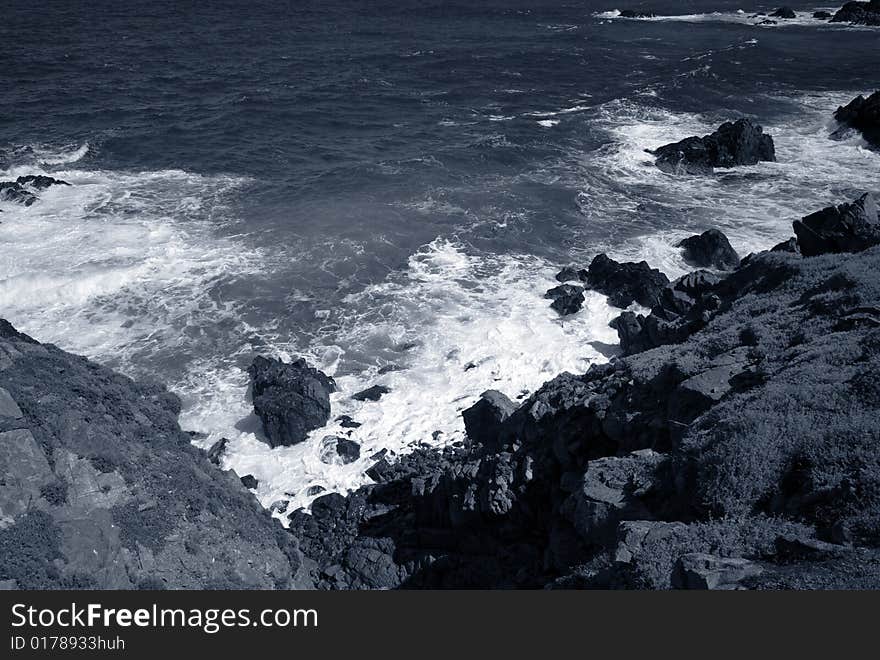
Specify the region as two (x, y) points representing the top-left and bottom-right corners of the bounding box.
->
(0, 321), (308, 589)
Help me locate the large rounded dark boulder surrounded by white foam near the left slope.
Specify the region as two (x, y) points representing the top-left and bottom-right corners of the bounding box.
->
(248, 356), (336, 447)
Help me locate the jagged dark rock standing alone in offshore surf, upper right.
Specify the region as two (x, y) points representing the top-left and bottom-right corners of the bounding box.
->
(653, 119), (776, 174)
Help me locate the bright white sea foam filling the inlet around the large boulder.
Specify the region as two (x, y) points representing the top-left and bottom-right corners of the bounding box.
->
(183, 240), (620, 510)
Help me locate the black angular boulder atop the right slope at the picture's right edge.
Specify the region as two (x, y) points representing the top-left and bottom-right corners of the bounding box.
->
(794, 193), (880, 257)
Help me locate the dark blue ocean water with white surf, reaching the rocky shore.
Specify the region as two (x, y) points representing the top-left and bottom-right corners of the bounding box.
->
(0, 0), (880, 515)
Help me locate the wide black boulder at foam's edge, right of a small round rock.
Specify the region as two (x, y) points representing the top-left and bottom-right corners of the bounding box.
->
(584, 253), (669, 307)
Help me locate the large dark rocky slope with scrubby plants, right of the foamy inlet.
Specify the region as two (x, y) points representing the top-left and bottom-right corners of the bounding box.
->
(280, 195), (880, 589)
